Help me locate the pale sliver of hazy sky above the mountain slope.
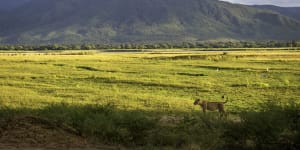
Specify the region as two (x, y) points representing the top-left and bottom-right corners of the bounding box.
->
(223, 0), (300, 7)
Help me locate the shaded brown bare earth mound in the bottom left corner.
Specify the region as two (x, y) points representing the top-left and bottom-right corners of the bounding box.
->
(0, 116), (122, 150)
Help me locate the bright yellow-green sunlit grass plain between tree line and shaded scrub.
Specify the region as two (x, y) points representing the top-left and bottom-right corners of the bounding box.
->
(0, 51), (300, 112)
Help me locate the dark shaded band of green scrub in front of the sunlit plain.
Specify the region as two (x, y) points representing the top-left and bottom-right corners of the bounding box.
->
(0, 103), (300, 149)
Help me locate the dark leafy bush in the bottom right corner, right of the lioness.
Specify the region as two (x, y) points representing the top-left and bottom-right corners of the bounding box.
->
(222, 102), (300, 149)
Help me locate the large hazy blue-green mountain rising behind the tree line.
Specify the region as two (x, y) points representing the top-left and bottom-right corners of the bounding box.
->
(0, 0), (300, 44)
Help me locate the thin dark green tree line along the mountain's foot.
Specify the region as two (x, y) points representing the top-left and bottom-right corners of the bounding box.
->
(0, 40), (300, 50)
